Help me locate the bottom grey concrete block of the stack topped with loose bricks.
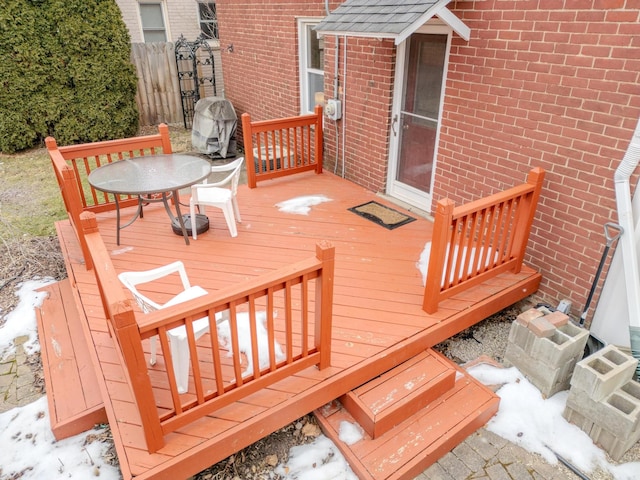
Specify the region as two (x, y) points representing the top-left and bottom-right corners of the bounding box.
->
(505, 343), (582, 397)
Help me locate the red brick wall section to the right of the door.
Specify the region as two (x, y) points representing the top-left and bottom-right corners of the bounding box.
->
(442, 0), (640, 316)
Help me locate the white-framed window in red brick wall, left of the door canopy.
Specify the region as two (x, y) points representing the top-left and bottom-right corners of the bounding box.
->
(298, 19), (324, 114)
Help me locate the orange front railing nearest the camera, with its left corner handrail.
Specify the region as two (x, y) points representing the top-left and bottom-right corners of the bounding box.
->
(81, 212), (335, 452)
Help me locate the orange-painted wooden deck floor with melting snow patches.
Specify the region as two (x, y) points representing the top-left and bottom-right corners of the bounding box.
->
(57, 173), (540, 479)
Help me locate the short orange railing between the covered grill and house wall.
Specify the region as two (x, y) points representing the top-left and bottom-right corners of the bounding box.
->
(242, 105), (323, 188)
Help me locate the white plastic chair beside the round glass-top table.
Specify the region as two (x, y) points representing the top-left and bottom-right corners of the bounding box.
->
(189, 157), (244, 240)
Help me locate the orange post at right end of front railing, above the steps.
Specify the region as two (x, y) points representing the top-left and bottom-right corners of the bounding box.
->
(315, 241), (336, 370)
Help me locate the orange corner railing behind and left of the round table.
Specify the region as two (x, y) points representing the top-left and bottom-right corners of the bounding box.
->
(45, 124), (173, 270)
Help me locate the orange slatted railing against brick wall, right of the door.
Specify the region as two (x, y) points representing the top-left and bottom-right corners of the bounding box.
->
(423, 168), (544, 313)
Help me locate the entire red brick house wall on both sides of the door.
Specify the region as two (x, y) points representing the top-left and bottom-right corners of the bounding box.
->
(217, 0), (640, 322)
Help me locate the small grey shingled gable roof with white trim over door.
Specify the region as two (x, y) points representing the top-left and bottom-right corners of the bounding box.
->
(315, 0), (471, 45)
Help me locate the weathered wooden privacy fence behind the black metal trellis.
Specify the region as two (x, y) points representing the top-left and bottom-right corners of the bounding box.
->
(131, 42), (224, 126)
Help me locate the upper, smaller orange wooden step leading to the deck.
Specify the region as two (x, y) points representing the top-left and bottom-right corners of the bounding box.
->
(340, 350), (456, 438)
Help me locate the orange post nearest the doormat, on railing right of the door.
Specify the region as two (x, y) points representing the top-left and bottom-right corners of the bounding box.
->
(422, 198), (454, 314)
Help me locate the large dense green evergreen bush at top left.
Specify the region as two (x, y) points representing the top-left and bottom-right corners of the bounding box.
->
(0, 0), (138, 153)
